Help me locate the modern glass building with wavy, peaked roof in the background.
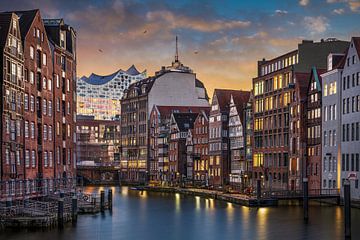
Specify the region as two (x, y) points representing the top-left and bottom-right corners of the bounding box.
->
(77, 65), (146, 120)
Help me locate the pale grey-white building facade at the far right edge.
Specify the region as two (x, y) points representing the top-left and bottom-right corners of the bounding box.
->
(341, 37), (360, 200)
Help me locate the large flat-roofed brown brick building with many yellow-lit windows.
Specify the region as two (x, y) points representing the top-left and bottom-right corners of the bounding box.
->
(253, 39), (348, 189)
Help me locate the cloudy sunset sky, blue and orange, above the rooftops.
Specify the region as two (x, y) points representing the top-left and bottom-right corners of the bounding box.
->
(0, 0), (360, 96)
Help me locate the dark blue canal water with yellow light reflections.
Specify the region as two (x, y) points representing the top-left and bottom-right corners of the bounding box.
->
(0, 187), (360, 240)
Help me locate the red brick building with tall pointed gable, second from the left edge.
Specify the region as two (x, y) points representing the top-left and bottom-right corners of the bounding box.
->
(16, 10), (54, 189)
